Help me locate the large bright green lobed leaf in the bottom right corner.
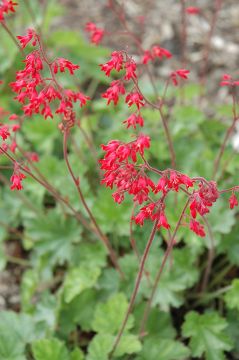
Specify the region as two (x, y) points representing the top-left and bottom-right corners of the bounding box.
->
(182, 311), (232, 360)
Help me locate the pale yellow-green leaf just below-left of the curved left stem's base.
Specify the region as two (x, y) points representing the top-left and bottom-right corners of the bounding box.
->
(63, 264), (101, 303)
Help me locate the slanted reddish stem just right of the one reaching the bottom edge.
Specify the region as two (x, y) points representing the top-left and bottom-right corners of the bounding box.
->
(139, 199), (189, 336)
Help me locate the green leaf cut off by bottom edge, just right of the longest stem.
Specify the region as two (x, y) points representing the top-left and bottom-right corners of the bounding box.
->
(137, 336), (190, 360)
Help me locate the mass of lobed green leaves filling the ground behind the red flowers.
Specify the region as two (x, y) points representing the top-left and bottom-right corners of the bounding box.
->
(0, 0), (239, 360)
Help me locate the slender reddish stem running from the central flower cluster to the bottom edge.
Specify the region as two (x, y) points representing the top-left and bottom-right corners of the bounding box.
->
(109, 219), (159, 359)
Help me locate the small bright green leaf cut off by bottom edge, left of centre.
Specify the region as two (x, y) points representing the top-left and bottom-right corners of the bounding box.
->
(32, 339), (69, 360)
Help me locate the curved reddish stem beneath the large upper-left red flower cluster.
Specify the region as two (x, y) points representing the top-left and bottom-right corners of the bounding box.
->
(63, 130), (123, 277)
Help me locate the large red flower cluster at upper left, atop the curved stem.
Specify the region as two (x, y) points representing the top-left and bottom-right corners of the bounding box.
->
(10, 29), (89, 126)
